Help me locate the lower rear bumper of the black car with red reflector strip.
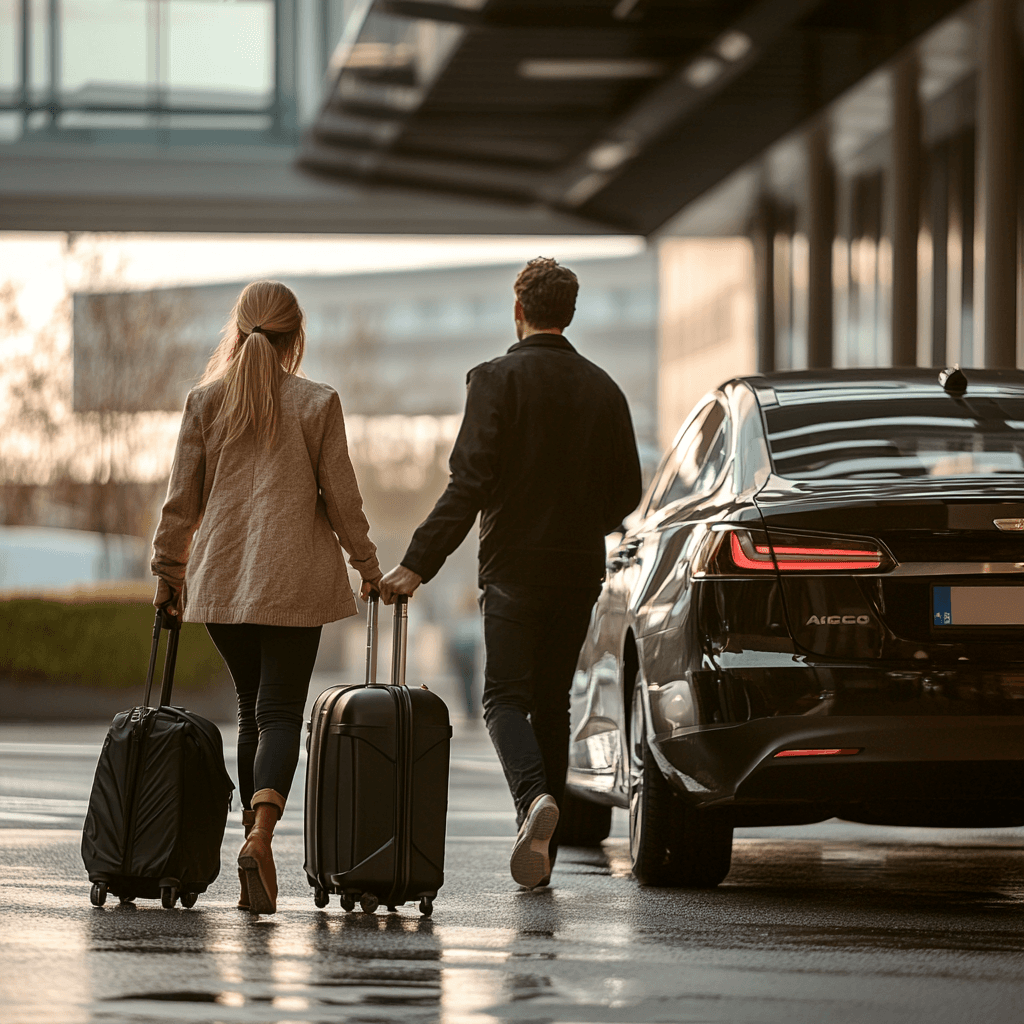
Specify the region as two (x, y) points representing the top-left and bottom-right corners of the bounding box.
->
(652, 716), (1024, 826)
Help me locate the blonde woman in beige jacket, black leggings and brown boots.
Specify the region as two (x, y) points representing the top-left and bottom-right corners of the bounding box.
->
(153, 281), (381, 913)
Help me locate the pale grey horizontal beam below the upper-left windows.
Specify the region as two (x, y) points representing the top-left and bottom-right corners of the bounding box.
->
(0, 144), (598, 234)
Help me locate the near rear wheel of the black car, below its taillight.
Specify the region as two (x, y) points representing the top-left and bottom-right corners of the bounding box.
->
(630, 693), (732, 889)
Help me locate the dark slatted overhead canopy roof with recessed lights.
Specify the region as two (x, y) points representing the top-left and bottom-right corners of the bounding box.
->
(300, 0), (962, 234)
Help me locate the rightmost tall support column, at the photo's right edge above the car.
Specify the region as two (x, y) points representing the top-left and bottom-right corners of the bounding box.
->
(975, 0), (1021, 367)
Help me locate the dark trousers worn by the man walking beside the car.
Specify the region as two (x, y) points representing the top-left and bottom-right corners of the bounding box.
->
(480, 583), (600, 862)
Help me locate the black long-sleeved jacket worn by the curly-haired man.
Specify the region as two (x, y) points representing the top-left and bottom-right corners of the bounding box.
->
(401, 334), (640, 587)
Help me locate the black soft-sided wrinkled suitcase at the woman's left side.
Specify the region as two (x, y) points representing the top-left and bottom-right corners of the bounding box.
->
(82, 611), (234, 908)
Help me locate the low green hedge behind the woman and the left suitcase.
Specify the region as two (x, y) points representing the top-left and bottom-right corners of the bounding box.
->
(0, 599), (226, 689)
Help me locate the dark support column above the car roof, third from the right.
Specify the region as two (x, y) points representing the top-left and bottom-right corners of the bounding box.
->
(807, 122), (836, 370)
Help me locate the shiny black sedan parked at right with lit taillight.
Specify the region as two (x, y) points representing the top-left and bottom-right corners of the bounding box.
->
(560, 370), (1024, 886)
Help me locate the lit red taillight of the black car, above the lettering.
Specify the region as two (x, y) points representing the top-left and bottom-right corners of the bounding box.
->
(706, 526), (895, 574)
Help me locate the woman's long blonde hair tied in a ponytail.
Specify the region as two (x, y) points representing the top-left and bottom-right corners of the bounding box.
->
(199, 281), (305, 447)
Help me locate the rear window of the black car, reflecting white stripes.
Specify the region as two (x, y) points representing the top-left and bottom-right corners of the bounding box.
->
(764, 394), (1024, 480)
